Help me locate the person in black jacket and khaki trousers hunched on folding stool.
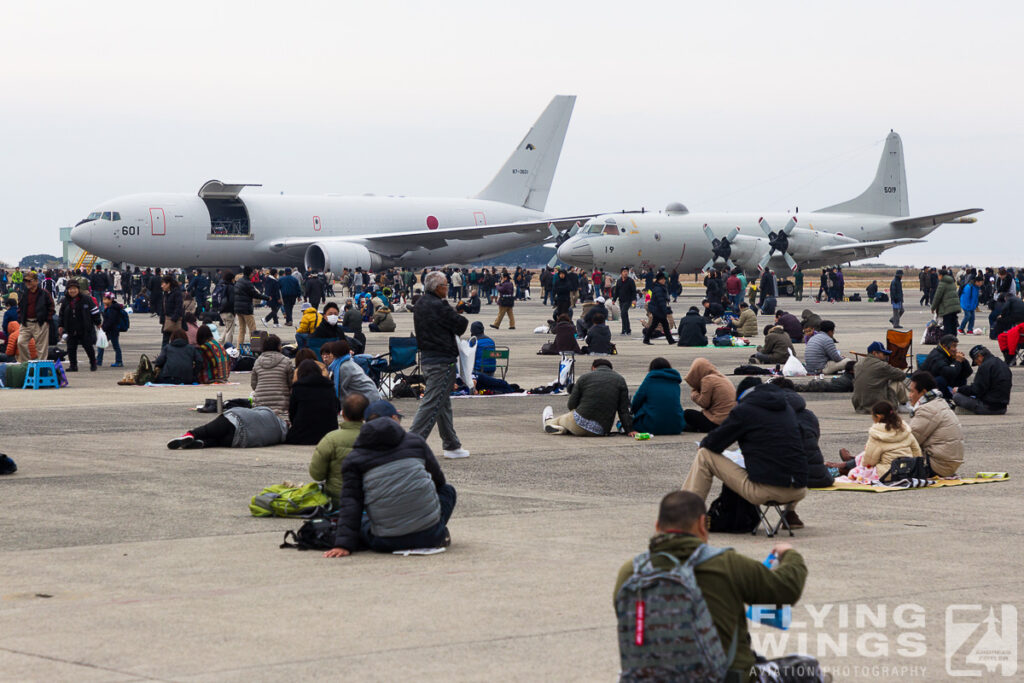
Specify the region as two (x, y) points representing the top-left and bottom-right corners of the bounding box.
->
(683, 377), (807, 527)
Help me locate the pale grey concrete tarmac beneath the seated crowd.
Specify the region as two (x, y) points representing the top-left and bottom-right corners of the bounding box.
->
(0, 291), (1024, 681)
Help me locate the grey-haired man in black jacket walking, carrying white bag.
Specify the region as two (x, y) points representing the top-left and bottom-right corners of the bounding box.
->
(409, 270), (469, 458)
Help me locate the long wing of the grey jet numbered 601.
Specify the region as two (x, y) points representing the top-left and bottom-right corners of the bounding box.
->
(270, 214), (596, 254)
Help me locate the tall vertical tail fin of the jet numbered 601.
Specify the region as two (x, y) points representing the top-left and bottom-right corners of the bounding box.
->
(476, 95), (575, 211)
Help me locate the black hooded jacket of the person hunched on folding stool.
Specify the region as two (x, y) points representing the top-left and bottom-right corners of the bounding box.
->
(698, 385), (808, 488)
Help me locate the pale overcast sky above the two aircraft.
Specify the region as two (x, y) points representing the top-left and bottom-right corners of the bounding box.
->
(0, 0), (1024, 264)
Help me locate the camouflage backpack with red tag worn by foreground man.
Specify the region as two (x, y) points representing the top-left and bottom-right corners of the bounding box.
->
(615, 545), (736, 682)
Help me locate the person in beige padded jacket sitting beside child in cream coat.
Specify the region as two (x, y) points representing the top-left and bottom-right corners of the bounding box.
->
(907, 371), (964, 477)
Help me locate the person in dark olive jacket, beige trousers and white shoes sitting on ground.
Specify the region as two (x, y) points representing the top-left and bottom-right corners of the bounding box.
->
(543, 358), (636, 436)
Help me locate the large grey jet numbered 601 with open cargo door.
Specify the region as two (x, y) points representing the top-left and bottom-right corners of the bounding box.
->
(71, 95), (593, 271)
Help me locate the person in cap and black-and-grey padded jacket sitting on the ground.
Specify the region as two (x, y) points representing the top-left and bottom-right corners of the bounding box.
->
(324, 400), (456, 557)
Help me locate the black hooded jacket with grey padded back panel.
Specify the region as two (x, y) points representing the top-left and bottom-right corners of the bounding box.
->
(334, 418), (445, 551)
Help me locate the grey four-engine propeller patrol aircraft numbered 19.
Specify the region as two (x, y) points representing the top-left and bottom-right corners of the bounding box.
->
(552, 132), (981, 272)
